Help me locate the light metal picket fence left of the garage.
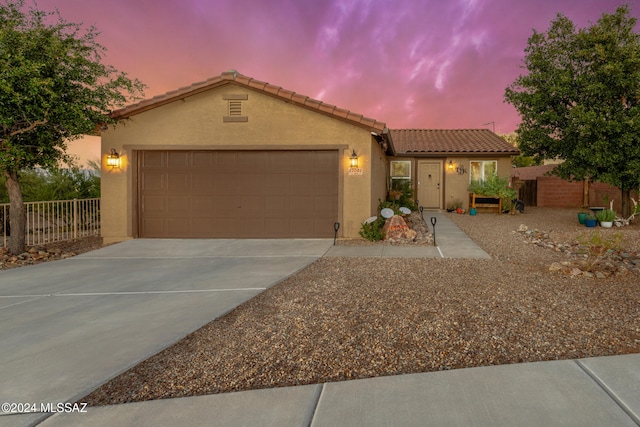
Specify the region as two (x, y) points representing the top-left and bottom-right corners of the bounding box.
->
(0, 199), (100, 247)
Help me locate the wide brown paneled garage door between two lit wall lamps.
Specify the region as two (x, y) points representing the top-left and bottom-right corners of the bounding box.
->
(138, 150), (339, 238)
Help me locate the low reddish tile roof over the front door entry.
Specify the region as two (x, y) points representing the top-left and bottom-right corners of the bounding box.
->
(389, 129), (520, 155)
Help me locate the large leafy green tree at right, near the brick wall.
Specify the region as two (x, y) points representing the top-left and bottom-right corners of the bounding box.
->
(505, 5), (640, 216)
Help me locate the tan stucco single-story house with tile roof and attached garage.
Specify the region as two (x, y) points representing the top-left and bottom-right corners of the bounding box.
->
(101, 70), (517, 243)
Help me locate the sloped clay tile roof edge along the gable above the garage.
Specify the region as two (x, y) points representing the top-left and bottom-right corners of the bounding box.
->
(111, 70), (386, 132)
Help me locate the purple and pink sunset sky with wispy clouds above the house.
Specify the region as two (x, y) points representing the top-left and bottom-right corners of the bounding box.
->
(38, 0), (640, 133)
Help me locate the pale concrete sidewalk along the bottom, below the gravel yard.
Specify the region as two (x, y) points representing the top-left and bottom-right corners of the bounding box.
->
(42, 354), (640, 427)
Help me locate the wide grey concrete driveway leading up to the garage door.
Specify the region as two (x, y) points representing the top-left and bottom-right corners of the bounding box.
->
(0, 239), (333, 425)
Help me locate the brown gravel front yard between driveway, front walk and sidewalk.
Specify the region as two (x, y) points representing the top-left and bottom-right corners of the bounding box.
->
(80, 208), (640, 405)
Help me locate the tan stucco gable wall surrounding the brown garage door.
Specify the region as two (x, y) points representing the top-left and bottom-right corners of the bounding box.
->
(101, 85), (384, 242)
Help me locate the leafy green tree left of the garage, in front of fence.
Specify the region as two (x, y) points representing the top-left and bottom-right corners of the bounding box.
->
(0, 0), (144, 253)
